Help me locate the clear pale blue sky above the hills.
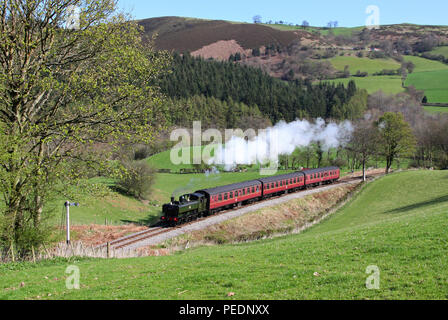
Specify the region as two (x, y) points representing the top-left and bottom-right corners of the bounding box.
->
(119, 0), (448, 27)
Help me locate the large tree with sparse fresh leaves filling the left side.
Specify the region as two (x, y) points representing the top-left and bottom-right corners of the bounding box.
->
(0, 0), (169, 255)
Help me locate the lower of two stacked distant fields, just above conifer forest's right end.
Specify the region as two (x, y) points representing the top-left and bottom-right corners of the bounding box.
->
(324, 76), (404, 94)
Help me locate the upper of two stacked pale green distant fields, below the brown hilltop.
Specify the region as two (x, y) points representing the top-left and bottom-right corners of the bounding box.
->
(329, 56), (400, 75)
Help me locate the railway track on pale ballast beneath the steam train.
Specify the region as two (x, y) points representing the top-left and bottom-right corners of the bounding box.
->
(98, 177), (368, 250)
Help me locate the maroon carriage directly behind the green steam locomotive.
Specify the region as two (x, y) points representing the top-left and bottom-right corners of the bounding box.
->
(196, 180), (262, 214)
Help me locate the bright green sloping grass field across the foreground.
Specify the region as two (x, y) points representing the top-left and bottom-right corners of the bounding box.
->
(0, 171), (448, 299)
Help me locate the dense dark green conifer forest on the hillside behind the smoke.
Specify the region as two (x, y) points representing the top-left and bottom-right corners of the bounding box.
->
(160, 54), (367, 123)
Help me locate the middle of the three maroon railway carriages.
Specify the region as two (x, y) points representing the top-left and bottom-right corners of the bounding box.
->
(259, 172), (305, 198)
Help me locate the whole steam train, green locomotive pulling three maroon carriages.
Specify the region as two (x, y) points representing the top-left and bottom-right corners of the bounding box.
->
(161, 167), (340, 226)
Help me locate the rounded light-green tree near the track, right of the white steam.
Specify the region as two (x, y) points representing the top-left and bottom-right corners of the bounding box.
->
(377, 112), (416, 174)
